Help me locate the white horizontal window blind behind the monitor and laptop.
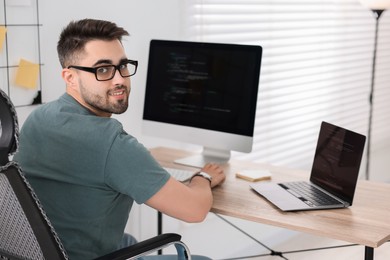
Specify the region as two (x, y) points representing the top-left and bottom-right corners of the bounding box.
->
(182, 0), (390, 173)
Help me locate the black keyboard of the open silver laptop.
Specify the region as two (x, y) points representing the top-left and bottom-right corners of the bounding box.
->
(279, 182), (342, 207)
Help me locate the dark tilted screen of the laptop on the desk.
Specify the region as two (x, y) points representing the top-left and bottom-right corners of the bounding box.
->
(310, 122), (366, 205)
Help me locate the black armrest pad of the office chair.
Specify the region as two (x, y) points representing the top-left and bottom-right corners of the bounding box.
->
(95, 233), (185, 260)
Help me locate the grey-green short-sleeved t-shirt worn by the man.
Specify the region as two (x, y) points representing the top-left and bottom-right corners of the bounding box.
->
(14, 94), (169, 260)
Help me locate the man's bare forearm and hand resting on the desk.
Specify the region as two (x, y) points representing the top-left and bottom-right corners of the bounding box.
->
(146, 164), (225, 222)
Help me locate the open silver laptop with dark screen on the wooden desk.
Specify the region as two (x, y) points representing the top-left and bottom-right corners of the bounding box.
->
(250, 122), (366, 211)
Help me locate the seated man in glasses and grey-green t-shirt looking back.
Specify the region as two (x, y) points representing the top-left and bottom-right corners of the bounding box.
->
(14, 19), (225, 260)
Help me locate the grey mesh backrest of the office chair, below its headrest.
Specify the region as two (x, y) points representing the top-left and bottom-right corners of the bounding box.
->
(0, 162), (67, 260)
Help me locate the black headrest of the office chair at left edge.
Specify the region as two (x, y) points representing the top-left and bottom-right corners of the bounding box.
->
(0, 89), (19, 165)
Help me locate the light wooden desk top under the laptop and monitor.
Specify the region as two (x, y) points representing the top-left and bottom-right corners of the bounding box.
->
(151, 147), (390, 247)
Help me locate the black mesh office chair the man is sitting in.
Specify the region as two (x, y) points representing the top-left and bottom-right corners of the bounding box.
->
(0, 89), (191, 260)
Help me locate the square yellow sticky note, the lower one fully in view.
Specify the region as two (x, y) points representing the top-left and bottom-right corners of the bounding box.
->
(15, 59), (39, 89)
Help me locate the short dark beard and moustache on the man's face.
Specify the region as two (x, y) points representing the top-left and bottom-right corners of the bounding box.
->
(80, 82), (129, 114)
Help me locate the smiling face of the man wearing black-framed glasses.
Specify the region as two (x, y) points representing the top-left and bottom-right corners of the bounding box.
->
(67, 40), (131, 117)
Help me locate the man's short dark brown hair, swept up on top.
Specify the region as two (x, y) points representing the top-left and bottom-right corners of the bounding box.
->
(57, 19), (129, 68)
